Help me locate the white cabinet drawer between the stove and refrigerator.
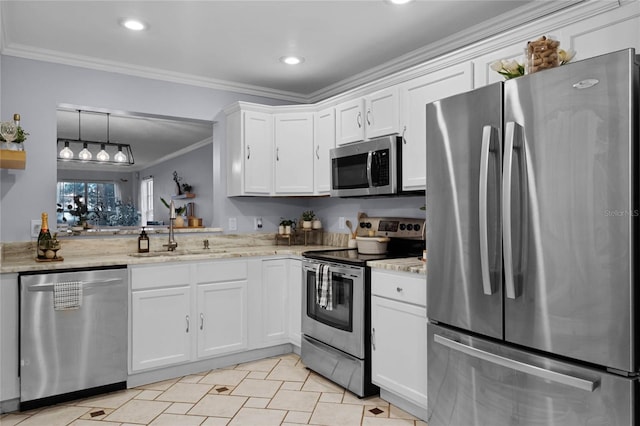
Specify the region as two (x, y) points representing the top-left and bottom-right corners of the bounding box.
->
(371, 271), (427, 306)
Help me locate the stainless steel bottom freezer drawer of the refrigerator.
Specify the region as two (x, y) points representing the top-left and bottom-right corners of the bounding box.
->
(426, 324), (640, 426)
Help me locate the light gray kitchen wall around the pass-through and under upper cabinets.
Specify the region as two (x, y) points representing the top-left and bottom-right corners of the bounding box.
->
(0, 56), (424, 242)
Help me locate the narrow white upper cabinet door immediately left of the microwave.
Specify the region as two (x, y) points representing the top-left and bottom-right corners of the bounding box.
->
(313, 108), (336, 194)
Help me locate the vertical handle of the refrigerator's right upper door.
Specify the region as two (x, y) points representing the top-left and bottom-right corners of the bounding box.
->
(502, 121), (522, 299)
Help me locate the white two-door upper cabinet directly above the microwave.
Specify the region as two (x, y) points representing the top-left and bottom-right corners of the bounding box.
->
(336, 86), (400, 145)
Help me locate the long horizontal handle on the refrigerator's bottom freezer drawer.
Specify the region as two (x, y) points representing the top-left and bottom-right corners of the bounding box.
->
(433, 334), (600, 392)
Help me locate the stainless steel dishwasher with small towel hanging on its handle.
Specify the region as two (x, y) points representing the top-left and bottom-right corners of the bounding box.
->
(20, 266), (128, 410)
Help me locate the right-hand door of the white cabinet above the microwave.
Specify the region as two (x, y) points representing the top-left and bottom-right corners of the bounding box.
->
(364, 86), (400, 139)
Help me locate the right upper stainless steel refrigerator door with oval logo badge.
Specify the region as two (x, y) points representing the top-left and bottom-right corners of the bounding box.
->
(503, 50), (640, 371)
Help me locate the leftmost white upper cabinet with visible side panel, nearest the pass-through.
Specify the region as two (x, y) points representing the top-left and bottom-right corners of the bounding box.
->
(227, 109), (273, 196)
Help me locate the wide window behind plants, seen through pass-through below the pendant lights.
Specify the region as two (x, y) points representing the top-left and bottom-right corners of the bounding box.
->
(56, 181), (139, 226)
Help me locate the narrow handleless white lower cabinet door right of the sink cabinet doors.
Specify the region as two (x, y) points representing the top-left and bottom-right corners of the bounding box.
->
(262, 259), (289, 344)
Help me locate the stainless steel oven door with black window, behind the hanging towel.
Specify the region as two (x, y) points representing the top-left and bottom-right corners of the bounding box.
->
(302, 259), (365, 359)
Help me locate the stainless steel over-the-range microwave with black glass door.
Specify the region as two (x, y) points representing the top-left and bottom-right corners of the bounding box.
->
(330, 135), (424, 197)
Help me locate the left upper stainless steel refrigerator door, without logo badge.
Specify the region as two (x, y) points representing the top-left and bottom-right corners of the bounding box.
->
(426, 83), (503, 338)
